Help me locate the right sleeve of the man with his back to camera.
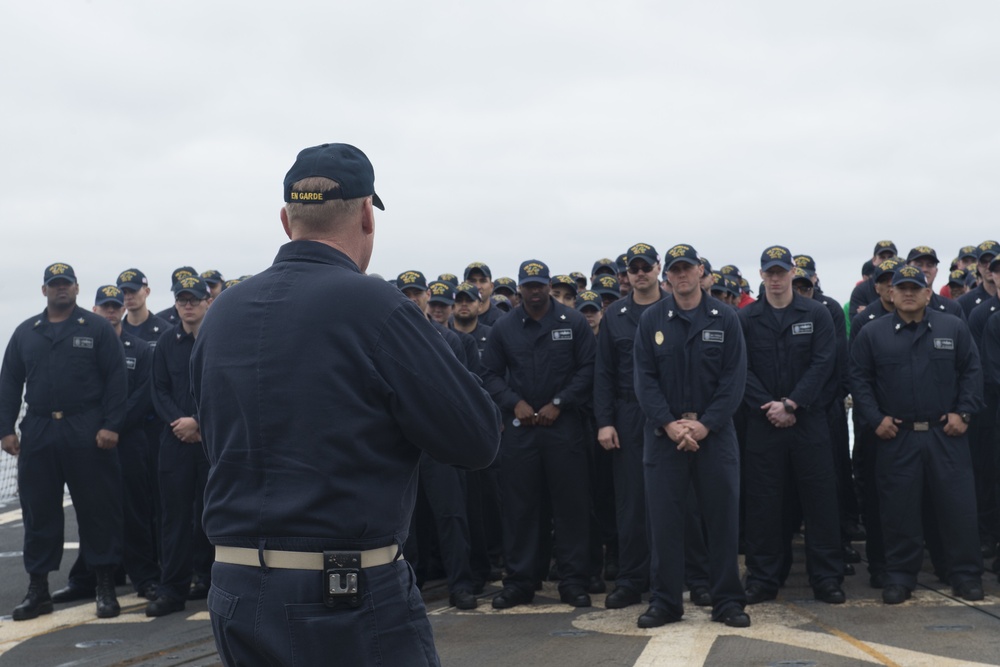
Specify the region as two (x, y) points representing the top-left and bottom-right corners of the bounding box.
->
(376, 307), (500, 470)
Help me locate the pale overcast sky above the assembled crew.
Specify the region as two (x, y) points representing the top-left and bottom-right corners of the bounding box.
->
(0, 0), (1000, 341)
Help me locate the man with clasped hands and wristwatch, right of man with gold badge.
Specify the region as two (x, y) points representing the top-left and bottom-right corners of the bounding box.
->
(739, 246), (845, 604)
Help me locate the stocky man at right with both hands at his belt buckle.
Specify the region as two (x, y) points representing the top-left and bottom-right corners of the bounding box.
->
(851, 266), (983, 604)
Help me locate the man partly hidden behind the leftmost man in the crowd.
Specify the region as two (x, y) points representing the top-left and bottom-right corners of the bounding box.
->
(52, 285), (160, 603)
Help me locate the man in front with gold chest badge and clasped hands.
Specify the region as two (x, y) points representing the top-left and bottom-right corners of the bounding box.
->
(635, 245), (750, 628)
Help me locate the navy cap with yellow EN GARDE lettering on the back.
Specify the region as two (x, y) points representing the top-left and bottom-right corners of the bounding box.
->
(285, 144), (385, 211)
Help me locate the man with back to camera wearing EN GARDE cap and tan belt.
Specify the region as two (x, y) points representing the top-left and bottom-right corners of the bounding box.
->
(191, 144), (500, 665)
